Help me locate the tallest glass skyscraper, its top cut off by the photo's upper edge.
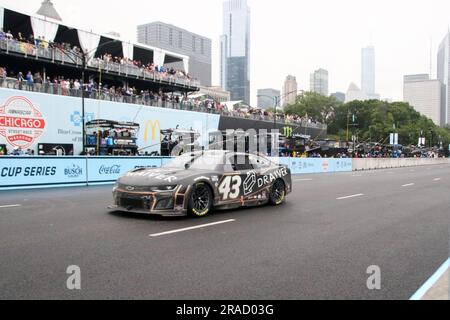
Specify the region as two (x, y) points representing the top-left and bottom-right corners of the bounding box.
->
(220, 0), (250, 104)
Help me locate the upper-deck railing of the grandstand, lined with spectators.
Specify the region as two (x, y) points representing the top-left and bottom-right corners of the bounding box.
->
(0, 39), (200, 88)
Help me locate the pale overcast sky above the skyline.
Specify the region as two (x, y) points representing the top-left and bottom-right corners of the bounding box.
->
(0, 0), (450, 104)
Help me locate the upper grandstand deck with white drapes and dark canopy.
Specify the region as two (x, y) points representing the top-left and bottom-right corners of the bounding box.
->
(0, 4), (199, 93)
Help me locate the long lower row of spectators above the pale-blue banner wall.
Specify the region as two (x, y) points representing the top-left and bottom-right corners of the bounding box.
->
(0, 67), (326, 125)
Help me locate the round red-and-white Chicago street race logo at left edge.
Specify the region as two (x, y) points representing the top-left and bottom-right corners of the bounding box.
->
(0, 96), (46, 149)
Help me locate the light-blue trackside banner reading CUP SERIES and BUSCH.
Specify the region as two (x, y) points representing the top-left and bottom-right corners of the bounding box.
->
(0, 157), (86, 190)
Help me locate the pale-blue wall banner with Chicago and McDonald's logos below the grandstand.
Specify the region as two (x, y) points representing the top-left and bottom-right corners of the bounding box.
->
(0, 88), (220, 155)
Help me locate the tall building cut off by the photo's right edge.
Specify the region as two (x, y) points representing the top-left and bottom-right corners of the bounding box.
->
(437, 31), (450, 126)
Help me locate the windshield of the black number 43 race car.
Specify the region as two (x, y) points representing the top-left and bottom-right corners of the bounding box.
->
(163, 152), (224, 171)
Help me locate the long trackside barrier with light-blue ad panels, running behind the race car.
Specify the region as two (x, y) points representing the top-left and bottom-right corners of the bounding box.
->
(0, 157), (450, 191)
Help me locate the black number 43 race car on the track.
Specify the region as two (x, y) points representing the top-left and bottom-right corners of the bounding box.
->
(109, 151), (292, 217)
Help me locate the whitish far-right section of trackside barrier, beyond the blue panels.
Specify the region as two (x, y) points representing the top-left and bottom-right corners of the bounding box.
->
(353, 158), (450, 171)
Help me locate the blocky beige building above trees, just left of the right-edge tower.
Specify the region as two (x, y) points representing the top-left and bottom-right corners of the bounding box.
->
(403, 74), (442, 125)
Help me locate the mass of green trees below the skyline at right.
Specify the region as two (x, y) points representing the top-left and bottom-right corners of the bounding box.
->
(285, 97), (450, 147)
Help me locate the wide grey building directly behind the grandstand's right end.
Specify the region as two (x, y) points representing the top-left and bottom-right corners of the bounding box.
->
(137, 22), (212, 86)
